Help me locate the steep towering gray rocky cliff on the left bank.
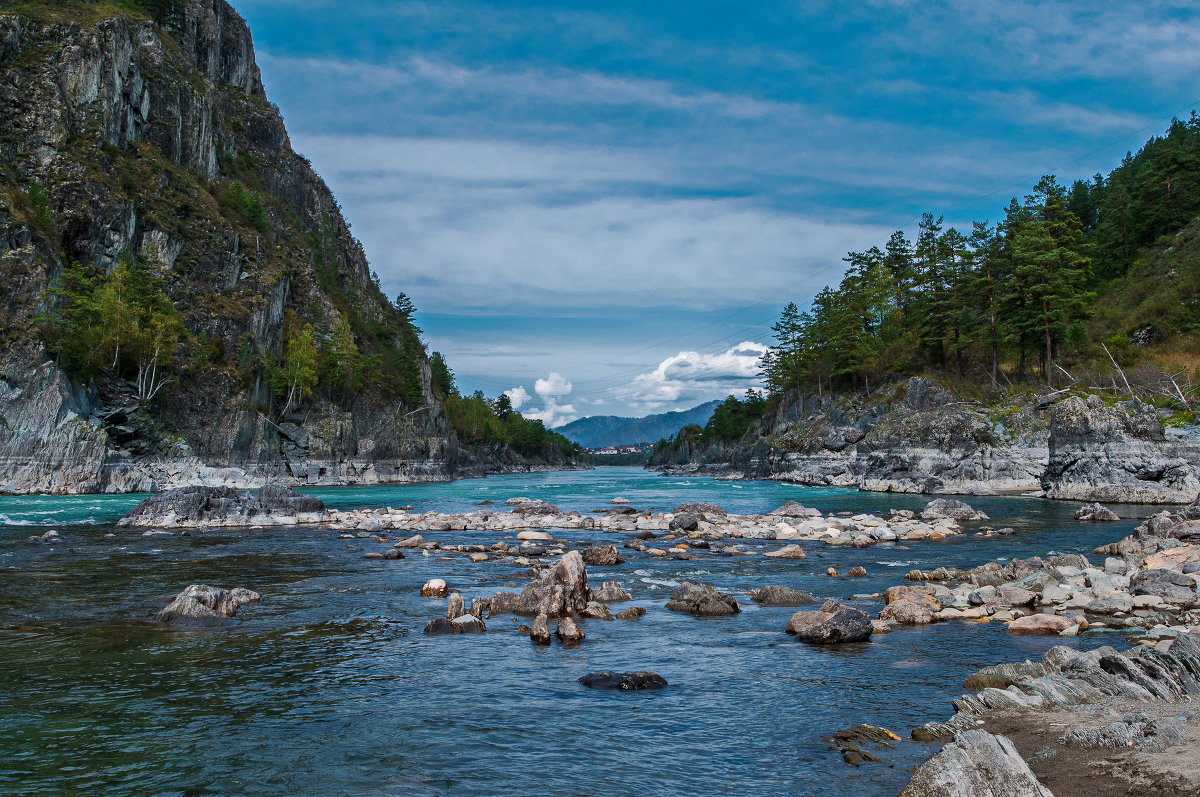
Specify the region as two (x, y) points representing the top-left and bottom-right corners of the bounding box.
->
(0, 0), (580, 492)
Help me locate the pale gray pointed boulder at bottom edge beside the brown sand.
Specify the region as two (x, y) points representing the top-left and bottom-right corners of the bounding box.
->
(900, 729), (1054, 797)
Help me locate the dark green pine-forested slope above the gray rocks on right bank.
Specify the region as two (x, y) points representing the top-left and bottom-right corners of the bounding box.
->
(764, 115), (1200, 394)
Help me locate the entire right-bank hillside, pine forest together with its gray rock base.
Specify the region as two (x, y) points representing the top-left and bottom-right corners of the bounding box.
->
(650, 114), (1200, 501)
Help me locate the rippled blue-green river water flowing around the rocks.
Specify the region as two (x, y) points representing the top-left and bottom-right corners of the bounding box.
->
(0, 468), (1150, 796)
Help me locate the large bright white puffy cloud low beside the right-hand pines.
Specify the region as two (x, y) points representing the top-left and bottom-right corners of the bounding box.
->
(612, 341), (767, 411)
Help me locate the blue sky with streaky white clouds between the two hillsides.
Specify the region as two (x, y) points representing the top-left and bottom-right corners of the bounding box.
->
(234, 0), (1200, 425)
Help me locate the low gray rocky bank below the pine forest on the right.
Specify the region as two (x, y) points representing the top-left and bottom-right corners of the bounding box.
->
(647, 379), (1200, 503)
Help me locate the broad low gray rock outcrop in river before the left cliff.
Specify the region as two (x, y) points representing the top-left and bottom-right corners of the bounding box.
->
(116, 485), (325, 528)
